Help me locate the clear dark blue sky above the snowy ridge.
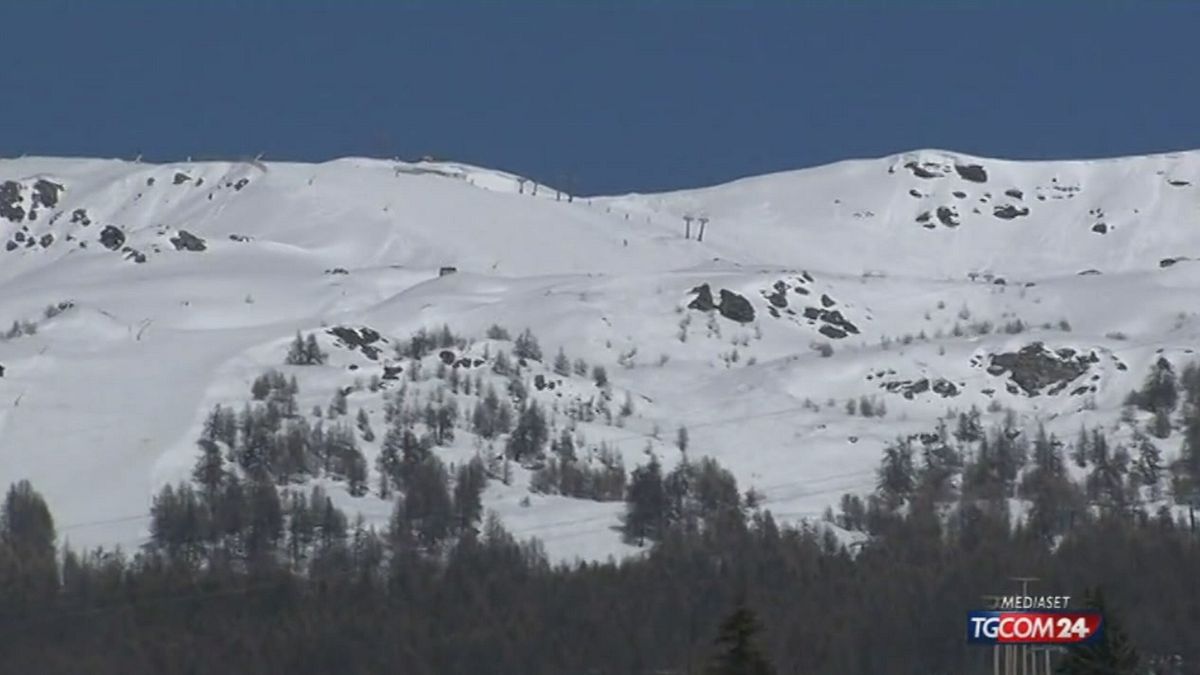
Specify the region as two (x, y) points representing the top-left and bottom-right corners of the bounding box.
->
(0, 0), (1200, 193)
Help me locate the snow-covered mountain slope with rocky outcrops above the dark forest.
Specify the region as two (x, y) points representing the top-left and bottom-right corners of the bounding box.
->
(0, 150), (1200, 558)
